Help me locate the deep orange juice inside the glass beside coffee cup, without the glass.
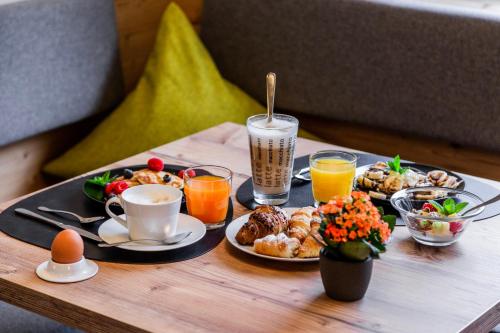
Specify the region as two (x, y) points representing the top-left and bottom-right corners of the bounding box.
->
(184, 176), (231, 223)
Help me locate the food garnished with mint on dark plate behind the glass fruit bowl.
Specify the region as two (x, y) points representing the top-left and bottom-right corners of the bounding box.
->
(356, 155), (462, 200)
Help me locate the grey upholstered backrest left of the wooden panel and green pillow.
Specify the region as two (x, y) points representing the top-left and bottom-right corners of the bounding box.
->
(0, 0), (122, 145)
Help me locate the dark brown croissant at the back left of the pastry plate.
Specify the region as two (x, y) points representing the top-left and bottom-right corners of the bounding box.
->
(236, 205), (288, 245)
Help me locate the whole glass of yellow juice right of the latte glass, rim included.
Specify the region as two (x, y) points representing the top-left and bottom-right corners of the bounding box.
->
(309, 150), (358, 206)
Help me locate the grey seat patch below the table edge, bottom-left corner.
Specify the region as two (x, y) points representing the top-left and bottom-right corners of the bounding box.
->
(0, 301), (81, 333)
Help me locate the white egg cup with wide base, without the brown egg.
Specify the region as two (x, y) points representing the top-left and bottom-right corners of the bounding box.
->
(36, 257), (99, 283)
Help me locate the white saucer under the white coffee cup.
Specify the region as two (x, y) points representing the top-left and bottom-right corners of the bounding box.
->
(98, 214), (207, 252)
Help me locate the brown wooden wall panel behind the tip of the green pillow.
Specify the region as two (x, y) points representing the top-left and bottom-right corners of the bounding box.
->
(115, 0), (203, 92)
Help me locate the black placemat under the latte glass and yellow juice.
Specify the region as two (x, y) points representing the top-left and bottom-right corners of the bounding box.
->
(236, 153), (500, 225)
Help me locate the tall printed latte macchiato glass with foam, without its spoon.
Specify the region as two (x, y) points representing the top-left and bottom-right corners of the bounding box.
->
(247, 114), (299, 205)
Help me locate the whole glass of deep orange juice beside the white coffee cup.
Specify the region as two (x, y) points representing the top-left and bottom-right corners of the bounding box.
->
(184, 165), (233, 229)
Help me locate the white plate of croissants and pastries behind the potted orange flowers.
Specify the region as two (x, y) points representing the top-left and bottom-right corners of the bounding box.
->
(226, 205), (323, 262)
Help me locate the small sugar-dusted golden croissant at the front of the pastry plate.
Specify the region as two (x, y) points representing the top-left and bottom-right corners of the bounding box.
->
(253, 233), (300, 258)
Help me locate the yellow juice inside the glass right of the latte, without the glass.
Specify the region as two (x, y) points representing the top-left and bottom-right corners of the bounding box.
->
(311, 158), (356, 202)
